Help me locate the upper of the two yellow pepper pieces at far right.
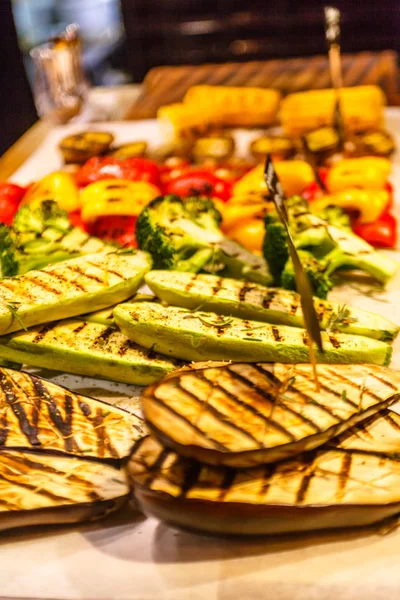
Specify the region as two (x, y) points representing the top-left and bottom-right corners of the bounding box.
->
(326, 156), (391, 194)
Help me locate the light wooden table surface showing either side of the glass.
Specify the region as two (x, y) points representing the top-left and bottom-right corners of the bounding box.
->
(0, 84), (141, 181)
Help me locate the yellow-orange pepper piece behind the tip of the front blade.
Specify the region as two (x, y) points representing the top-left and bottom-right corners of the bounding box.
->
(233, 160), (315, 196)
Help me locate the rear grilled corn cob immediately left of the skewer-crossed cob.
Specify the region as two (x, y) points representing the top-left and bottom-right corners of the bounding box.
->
(184, 85), (280, 127)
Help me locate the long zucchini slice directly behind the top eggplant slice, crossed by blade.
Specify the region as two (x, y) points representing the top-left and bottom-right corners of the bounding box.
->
(114, 302), (392, 365)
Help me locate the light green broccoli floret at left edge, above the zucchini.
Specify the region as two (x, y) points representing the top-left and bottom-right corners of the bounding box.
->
(0, 200), (112, 277)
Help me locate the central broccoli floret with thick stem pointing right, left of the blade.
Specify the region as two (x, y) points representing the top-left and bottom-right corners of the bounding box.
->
(136, 195), (271, 285)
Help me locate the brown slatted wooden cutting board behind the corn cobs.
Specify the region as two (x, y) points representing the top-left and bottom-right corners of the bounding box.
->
(126, 50), (400, 120)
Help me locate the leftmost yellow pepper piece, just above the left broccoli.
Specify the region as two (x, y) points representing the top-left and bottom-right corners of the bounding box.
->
(23, 171), (81, 212)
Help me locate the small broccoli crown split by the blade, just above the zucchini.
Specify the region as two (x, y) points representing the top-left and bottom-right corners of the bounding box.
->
(281, 250), (333, 299)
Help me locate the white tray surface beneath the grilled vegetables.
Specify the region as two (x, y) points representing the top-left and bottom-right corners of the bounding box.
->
(0, 109), (400, 600)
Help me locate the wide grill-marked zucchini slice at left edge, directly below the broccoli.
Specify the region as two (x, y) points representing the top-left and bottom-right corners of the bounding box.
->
(0, 251), (151, 334)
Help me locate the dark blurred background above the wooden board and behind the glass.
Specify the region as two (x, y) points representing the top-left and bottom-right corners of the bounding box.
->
(0, 0), (400, 151)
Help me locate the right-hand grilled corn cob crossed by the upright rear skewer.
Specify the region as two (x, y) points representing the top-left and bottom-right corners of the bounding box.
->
(280, 85), (385, 137)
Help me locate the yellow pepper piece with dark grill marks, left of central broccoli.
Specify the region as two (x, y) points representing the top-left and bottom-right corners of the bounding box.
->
(81, 179), (161, 222)
